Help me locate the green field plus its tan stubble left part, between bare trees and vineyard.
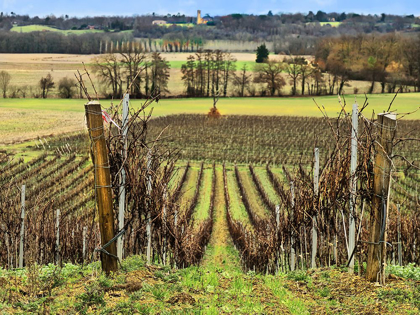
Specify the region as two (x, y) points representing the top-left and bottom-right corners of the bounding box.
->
(0, 93), (420, 145)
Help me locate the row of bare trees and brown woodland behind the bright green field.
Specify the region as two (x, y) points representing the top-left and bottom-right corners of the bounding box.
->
(0, 34), (420, 98)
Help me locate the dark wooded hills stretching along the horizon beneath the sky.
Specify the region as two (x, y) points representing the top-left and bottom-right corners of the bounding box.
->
(0, 11), (420, 55)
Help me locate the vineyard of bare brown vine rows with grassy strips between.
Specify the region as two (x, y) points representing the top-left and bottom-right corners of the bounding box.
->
(0, 106), (420, 312)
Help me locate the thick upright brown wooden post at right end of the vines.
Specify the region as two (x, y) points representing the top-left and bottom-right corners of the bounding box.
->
(366, 113), (397, 284)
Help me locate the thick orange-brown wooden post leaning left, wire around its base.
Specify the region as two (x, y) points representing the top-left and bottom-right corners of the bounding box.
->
(85, 101), (118, 275)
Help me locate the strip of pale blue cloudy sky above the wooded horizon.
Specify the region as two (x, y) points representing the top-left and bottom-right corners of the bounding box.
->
(0, 0), (420, 17)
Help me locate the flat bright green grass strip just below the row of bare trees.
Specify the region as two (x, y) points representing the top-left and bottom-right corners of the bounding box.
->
(0, 93), (420, 119)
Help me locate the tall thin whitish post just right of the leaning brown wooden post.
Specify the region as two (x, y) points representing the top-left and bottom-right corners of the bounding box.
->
(117, 94), (130, 261)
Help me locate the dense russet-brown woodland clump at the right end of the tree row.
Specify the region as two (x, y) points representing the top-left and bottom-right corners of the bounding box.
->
(315, 34), (420, 94)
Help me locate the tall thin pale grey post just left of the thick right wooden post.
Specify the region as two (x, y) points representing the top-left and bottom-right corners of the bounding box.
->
(348, 104), (359, 273)
